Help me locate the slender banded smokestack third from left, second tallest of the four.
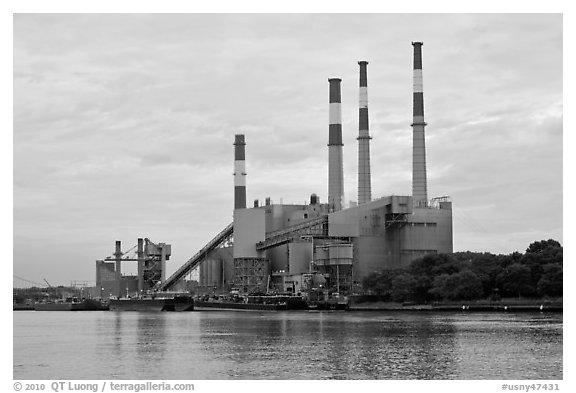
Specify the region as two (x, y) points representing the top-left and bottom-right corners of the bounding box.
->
(358, 61), (372, 205)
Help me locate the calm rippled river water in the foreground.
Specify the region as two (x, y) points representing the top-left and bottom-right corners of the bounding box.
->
(13, 311), (563, 380)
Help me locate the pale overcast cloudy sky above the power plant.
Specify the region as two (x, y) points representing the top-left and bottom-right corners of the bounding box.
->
(13, 14), (563, 285)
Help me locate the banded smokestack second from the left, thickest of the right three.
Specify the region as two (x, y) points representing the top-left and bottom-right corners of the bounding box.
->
(328, 78), (344, 211)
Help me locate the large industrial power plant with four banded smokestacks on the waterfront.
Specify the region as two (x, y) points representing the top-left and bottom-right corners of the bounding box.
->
(97, 42), (453, 295)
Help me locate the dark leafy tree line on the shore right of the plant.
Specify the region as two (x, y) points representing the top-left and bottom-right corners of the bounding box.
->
(362, 239), (562, 304)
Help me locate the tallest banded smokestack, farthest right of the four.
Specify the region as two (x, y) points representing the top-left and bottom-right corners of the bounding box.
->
(412, 42), (428, 206)
